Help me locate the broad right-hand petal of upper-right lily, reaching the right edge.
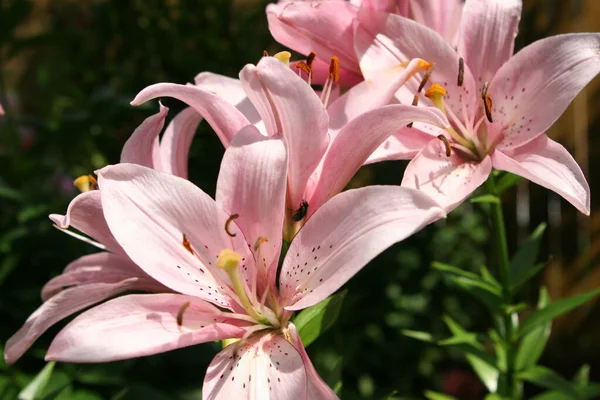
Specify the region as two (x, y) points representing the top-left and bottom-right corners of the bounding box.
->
(488, 33), (600, 150)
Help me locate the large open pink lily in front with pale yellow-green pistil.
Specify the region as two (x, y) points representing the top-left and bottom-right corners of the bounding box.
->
(47, 125), (444, 399)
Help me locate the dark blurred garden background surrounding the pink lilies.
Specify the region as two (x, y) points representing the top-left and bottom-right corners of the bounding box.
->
(0, 0), (600, 400)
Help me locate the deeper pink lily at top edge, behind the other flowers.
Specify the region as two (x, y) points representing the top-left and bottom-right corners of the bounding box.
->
(267, 0), (462, 87)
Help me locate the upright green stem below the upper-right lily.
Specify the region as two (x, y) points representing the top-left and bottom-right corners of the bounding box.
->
(486, 176), (521, 399)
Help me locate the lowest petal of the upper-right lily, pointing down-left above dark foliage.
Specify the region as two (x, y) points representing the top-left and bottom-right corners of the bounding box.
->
(402, 138), (492, 212)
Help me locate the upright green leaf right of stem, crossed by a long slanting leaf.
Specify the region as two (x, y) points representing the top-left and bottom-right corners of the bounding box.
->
(515, 288), (552, 371)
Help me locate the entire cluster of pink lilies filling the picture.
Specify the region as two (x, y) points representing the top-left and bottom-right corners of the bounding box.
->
(4, 0), (600, 400)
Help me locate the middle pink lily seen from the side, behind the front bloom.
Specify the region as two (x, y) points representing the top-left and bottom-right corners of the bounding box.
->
(132, 57), (448, 241)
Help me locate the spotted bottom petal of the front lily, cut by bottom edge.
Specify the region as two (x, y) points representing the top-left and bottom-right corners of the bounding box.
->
(202, 333), (307, 400)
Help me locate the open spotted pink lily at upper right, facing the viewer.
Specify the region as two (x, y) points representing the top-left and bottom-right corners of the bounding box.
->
(355, 0), (600, 215)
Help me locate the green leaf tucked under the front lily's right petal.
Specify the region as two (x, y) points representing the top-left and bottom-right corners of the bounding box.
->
(294, 290), (346, 347)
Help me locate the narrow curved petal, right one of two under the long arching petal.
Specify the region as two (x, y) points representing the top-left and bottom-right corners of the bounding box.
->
(158, 107), (202, 179)
